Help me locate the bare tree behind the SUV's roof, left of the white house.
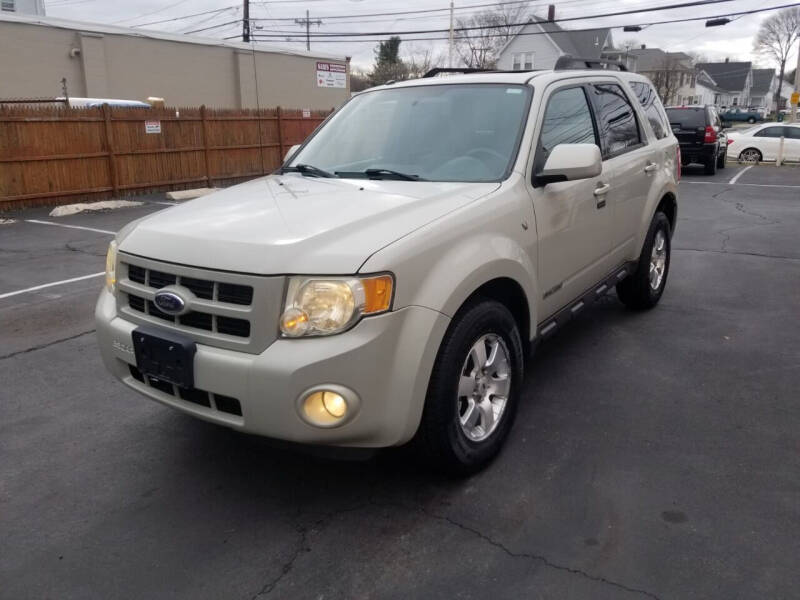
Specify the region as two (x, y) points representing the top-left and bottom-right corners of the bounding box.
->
(455, 4), (530, 69)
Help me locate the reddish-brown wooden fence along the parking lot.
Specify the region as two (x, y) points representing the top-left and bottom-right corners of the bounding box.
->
(0, 105), (330, 211)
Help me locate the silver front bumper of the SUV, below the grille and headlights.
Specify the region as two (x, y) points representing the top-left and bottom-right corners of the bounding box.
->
(95, 290), (450, 447)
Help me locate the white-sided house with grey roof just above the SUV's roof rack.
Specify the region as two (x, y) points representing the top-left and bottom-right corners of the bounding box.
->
(497, 18), (613, 71)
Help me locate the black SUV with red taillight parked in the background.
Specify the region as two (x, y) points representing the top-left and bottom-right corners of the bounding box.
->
(666, 105), (728, 175)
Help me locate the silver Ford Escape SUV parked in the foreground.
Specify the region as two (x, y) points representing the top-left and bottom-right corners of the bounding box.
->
(96, 63), (680, 473)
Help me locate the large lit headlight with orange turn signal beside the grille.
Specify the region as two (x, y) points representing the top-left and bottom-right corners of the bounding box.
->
(281, 275), (394, 337)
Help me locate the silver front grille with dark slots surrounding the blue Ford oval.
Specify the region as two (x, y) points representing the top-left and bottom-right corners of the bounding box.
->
(117, 252), (286, 354)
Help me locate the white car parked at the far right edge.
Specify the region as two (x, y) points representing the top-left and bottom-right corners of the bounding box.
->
(728, 123), (800, 162)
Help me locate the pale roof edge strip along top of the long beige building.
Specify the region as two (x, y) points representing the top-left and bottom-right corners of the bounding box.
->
(0, 12), (346, 62)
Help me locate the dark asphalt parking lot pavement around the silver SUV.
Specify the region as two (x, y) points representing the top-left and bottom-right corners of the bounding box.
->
(0, 165), (800, 600)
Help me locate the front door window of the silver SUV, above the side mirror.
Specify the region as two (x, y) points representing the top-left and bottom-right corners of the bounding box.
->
(539, 88), (597, 165)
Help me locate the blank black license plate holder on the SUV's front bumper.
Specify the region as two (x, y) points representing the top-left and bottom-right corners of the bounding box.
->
(132, 325), (197, 389)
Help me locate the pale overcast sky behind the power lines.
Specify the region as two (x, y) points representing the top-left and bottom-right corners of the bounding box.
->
(46, 0), (794, 69)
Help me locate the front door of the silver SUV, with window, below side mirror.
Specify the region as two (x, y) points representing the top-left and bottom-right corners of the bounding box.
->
(529, 84), (614, 319)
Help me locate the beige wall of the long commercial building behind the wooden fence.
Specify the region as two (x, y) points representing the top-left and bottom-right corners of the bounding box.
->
(0, 20), (350, 109)
